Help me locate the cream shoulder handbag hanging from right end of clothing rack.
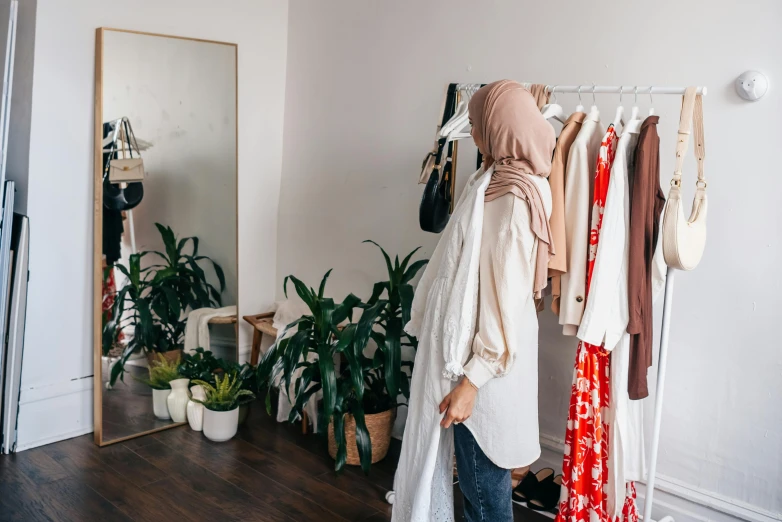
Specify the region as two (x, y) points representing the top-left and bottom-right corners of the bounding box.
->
(662, 87), (708, 270)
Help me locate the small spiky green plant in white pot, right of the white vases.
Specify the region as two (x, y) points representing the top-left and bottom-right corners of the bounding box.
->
(193, 372), (255, 442)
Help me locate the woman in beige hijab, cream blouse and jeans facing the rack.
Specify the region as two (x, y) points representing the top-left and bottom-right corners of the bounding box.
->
(392, 80), (555, 522)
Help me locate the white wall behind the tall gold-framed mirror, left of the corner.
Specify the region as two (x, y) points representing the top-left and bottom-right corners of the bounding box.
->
(19, 0), (288, 449)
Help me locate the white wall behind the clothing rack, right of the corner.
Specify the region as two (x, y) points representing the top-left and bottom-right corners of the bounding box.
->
(277, 0), (782, 520)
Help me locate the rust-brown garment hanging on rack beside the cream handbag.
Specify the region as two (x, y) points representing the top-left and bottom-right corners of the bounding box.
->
(627, 116), (665, 399)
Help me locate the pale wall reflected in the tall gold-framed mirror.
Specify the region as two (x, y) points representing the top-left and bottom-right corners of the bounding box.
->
(103, 31), (238, 304)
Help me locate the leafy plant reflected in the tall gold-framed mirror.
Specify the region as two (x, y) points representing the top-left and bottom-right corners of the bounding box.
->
(103, 223), (225, 385)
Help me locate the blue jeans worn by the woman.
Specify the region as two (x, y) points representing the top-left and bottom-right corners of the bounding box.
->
(453, 424), (513, 522)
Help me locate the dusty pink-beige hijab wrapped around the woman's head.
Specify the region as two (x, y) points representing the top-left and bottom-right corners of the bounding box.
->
(469, 80), (556, 297)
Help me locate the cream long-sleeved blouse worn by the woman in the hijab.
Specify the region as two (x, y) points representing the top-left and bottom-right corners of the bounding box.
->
(464, 177), (551, 469)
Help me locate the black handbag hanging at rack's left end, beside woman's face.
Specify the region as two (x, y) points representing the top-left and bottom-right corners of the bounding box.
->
(418, 83), (456, 234)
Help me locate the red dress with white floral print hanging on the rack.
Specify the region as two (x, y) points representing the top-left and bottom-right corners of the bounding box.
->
(557, 125), (638, 522)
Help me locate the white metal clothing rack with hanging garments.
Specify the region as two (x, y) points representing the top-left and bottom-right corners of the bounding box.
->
(410, 84), (707, 522)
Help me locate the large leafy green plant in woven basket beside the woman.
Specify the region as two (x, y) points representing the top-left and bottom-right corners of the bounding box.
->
(257, 244), (425, 472)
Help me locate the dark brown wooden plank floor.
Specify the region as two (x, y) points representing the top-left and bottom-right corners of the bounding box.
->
(0, 407), (548, 522)
